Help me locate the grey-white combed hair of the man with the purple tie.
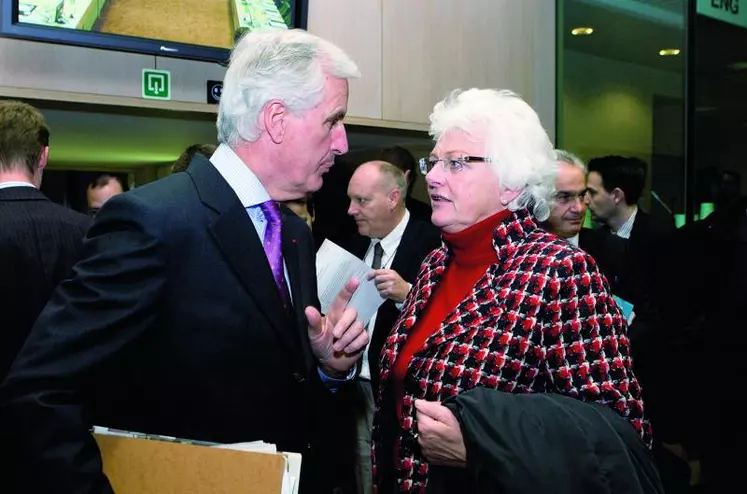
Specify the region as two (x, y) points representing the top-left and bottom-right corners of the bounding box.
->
(218, 29), (360, 146)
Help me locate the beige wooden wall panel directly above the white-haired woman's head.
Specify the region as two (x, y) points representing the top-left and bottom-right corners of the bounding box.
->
(382, 0), (555, 137)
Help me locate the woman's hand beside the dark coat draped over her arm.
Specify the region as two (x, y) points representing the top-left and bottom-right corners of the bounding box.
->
(415, 400), (467, 468)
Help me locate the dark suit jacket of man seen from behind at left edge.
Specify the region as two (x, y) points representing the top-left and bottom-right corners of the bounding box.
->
(0, 186), (91, 383)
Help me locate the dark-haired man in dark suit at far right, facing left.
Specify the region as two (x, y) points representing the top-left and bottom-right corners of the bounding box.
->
(587, 156), (689, 492)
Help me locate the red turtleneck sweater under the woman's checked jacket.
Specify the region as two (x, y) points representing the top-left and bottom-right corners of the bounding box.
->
(393, 209), (511, 417)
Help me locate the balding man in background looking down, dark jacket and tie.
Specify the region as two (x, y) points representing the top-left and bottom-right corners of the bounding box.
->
(343, 161), (441, 494)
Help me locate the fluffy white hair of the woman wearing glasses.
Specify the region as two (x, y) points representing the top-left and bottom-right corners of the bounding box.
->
(430, 88), (558, 221)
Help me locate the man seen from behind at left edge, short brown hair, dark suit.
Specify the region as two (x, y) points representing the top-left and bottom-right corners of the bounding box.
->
(0, 101), (91, 382)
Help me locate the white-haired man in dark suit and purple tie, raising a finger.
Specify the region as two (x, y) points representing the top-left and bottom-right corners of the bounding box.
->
(0, 31), (368, 493)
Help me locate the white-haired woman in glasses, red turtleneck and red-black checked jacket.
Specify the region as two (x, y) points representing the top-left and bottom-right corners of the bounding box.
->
(373, 89), (657, 494)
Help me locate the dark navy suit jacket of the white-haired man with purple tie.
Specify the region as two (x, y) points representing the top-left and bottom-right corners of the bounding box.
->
(0, 156), (332, 493)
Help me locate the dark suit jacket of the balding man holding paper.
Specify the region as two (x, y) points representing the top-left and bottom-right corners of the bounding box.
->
(344, 216), (441, 390)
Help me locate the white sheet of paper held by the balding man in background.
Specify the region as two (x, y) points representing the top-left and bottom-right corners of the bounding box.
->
(316, 240), (385, 326)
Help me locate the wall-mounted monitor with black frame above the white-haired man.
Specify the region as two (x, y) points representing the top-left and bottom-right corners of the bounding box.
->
(0, 0), (309, 62)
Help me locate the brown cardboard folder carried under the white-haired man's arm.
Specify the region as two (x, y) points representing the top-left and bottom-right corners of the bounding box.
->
(94, 434), (297, 494)
